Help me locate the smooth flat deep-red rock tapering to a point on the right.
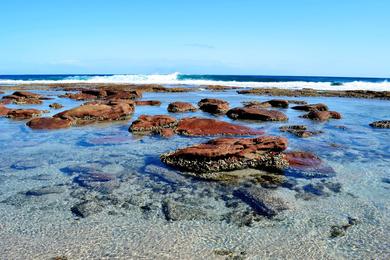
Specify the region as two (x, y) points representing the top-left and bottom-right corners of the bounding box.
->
(176, 117), (264, 136)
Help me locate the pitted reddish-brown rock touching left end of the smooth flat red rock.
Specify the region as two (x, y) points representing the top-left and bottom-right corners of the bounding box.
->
(129, 115), (177, 133)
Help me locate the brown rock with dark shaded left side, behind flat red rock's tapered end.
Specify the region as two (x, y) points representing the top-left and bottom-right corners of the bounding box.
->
(226, 107), (288, 121)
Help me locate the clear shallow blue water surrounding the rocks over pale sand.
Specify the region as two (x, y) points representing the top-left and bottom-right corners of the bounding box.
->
(0, 88), (390, 259)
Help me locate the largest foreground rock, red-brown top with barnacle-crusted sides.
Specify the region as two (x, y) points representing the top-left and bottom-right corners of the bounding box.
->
(161, 136), (288, 174)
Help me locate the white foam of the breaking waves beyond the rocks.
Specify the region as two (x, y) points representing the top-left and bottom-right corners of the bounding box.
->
(0, 72), (390, 91)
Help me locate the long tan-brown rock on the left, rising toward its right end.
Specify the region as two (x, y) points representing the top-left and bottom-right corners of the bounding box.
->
(54, 102), (134, 125)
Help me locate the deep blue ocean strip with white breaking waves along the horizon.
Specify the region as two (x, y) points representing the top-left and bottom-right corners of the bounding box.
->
(0, 72), (390, 91)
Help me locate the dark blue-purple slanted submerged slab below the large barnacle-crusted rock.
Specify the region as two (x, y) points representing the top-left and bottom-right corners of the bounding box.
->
(233, 186), (288, 218)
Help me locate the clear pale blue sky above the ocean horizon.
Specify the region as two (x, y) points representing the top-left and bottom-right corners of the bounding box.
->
(0, 0), (390, 77)
